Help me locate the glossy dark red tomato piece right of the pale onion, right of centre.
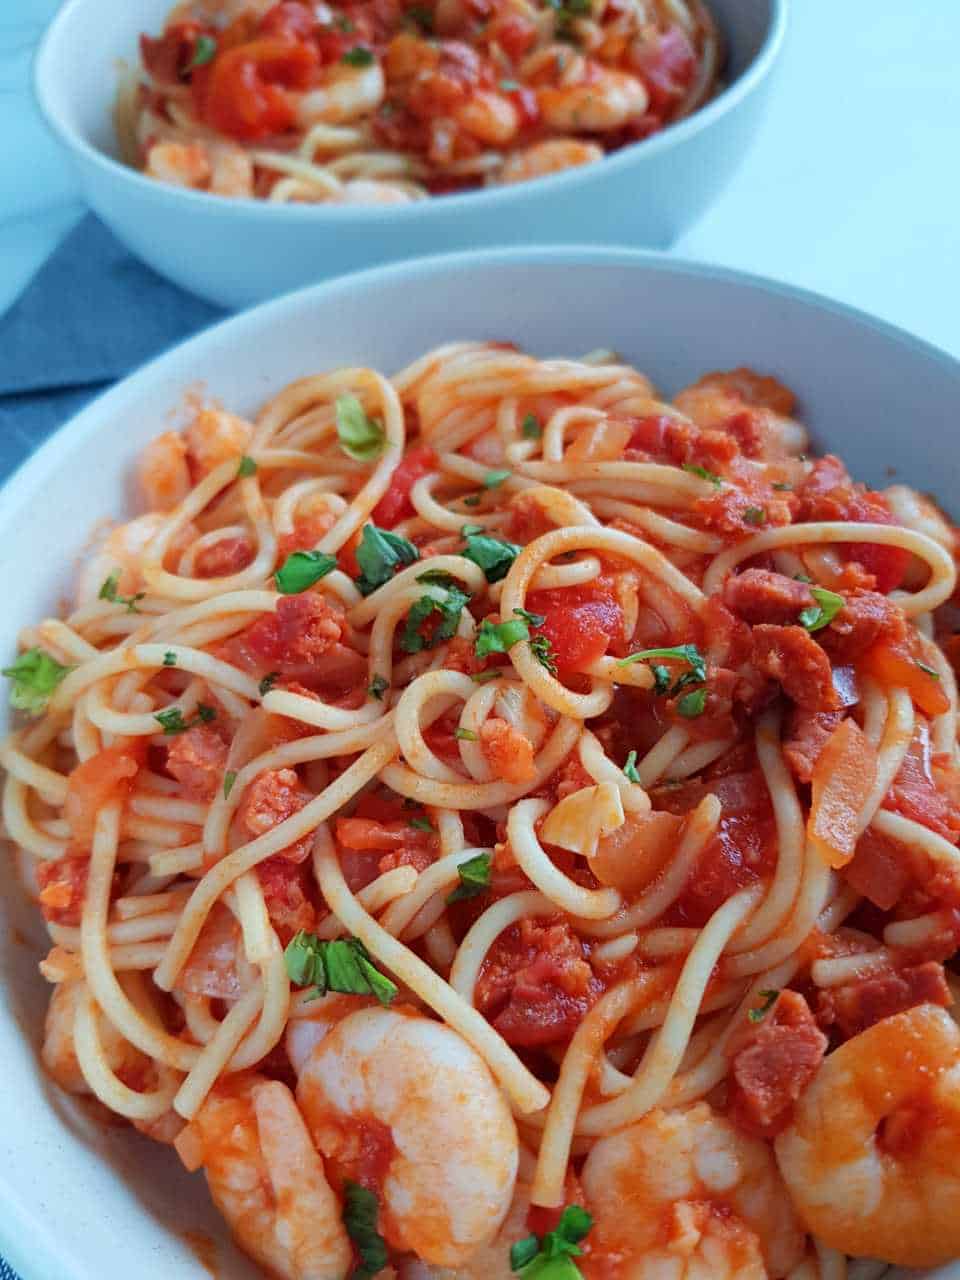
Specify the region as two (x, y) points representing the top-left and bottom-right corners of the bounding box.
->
(653, 769), (777, 925)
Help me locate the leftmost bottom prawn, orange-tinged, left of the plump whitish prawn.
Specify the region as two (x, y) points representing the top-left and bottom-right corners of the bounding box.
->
(174, 1074), (352, 1280)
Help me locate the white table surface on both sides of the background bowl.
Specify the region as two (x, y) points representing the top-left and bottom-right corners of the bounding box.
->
(0, 0), (960, 356)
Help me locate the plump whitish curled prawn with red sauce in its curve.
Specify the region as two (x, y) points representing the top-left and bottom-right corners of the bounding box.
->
(297, 1009), (518, 1267)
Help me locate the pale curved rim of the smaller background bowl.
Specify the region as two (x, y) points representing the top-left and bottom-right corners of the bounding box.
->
(31, 0), (791, 225)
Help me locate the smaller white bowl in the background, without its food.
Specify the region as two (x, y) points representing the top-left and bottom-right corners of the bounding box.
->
(35, 0), (787, 307)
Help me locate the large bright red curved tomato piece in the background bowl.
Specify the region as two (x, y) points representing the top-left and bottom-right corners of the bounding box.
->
(193, 38), (319, 142)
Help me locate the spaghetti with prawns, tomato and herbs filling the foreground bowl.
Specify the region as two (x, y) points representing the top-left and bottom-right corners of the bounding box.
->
(0, 343), (960, 1280)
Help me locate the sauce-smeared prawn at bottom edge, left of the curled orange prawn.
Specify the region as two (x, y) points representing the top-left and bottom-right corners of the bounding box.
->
(581, 1102), (804, 1280)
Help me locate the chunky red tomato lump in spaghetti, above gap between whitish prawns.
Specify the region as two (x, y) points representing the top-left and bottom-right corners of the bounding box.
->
(476, 919), (600, 1046)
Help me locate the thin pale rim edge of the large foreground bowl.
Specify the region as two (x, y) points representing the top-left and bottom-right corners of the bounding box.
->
(0, 246), (960, 1280)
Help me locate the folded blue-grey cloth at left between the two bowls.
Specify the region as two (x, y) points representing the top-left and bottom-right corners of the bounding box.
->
(0, 215), (224, 483)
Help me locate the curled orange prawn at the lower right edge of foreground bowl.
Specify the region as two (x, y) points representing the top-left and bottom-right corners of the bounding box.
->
(774, 1005), (960, 1267)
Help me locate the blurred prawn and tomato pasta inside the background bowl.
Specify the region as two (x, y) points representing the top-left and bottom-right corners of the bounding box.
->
(118, 0), (719, 204)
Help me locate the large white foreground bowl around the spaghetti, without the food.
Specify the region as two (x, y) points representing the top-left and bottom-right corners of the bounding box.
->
(0, 241), (960, 1280)
